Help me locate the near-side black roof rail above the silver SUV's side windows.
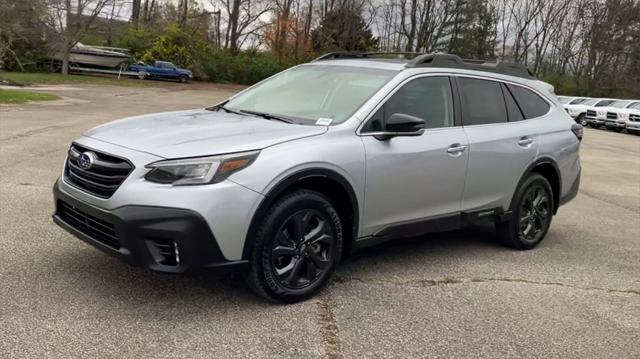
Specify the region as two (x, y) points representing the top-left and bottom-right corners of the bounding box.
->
(406, 54), (536, 79)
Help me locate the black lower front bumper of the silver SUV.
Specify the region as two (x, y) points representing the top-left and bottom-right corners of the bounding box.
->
(53, 182), (247, 273)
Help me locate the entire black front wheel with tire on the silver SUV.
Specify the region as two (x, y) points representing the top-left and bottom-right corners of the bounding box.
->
(245, 189), (343, 303)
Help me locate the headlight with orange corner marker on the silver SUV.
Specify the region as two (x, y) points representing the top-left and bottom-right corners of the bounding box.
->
(144, 151), (260, 186)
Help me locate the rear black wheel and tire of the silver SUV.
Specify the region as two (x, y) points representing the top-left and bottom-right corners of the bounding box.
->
(496, 173), (555, 250)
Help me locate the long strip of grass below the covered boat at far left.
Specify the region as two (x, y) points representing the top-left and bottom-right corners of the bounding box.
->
(0, 72), (157, 87)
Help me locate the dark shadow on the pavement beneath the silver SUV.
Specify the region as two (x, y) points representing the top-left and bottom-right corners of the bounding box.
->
(54, 226), (509, 311)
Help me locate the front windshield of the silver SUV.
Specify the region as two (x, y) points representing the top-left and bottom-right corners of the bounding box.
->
(225, 65), (397, 125)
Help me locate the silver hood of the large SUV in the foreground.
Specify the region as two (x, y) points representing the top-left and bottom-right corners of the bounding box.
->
(84, 109), (327, 158)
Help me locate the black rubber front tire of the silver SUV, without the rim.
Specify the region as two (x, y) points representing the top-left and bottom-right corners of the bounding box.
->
(252, 190), (343, 302)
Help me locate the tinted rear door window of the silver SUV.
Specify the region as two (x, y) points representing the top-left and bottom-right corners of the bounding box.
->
(458, 77), (508, 126)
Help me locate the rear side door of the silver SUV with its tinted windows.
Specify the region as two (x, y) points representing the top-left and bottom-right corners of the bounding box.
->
(457, 76), (549, 211)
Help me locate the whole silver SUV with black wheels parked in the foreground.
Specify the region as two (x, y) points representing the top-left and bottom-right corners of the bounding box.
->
(53, 53), (582, 302)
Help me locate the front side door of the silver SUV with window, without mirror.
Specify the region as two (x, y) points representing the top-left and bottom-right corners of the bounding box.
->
(360, 75), (467, 236)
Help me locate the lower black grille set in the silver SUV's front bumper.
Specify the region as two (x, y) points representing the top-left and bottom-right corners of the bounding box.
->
(57, 201), (120, 249)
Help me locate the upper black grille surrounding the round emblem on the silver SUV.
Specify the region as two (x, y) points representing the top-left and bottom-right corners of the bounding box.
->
(65, 144), (133, 198)
